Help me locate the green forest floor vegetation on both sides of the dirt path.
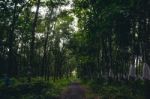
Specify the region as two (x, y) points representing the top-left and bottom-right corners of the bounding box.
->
(0, 78), (144, 99)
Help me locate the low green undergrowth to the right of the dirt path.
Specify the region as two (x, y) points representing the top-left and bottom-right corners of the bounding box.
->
(88, 81), (144, 99)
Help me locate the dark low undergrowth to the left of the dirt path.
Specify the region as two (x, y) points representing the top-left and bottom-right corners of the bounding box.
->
(0, 80), (60, 99)
